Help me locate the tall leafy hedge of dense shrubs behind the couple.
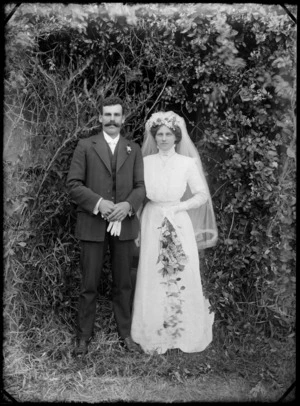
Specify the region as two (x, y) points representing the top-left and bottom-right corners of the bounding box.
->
(4, 3), (296, 348)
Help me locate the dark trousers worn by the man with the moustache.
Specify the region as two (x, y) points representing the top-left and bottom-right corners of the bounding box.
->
(77, 232), (134, 340)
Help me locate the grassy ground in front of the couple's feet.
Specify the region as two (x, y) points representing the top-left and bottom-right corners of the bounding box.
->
(3, 298), (296, 403)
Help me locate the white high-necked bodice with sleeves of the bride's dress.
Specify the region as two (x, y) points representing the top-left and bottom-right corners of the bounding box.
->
(144, 153), (207, 209)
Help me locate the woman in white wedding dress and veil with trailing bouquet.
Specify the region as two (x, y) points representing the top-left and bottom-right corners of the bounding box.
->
(131, 111), (218, 354)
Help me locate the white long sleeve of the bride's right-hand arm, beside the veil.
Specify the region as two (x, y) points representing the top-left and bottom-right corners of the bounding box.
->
(178, 160), (208, 211)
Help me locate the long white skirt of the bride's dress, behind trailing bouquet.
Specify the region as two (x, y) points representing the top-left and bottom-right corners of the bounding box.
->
(131, 201), (214, 354)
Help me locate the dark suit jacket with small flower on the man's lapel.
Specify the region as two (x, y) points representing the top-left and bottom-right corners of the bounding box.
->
(67, 132), (146, 241)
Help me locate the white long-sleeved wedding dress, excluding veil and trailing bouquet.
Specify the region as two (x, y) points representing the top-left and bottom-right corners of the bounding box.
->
(131, 149), (214, 354)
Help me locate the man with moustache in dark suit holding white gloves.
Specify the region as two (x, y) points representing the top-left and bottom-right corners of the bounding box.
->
(67, 97), (145, 356)
